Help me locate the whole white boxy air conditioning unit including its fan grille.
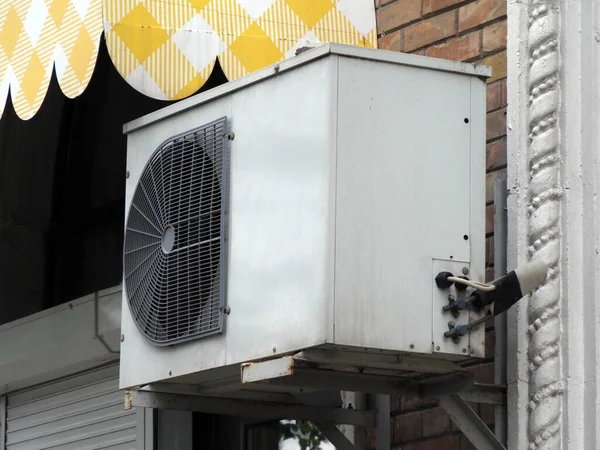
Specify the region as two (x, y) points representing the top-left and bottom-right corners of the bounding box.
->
(120, 44), (489, 395)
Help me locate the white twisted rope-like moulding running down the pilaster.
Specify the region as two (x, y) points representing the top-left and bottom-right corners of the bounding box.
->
(527, 1), (563, 450)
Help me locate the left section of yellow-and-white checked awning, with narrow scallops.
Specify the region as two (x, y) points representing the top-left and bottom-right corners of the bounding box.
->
(0, 0), (102, 120)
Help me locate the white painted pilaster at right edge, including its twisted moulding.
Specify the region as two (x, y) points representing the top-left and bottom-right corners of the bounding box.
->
(508, 0), (600, 450)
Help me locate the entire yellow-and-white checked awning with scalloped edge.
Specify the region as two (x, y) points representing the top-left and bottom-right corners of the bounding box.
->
(0, 0), (377, 120)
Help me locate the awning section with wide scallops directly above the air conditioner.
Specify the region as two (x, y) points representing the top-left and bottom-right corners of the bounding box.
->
(103, 0), (377, 100)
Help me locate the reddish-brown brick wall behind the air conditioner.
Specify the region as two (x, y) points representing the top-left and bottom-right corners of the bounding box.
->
(372, 0), (506, 450)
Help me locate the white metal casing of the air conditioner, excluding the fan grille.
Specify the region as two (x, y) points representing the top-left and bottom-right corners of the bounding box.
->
(120, 44), (489, 388)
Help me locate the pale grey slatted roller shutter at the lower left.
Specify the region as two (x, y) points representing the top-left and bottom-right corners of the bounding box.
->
(5, 365), (149, 450)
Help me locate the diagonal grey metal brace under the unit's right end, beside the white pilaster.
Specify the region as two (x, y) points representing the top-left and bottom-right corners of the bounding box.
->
(440, 394), (506, 450)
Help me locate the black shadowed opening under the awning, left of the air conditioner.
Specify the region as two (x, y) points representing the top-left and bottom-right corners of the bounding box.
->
(0, 34), (227, 325)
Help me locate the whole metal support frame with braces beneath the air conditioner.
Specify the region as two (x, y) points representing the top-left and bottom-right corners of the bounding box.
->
(125, 355), (506, 450)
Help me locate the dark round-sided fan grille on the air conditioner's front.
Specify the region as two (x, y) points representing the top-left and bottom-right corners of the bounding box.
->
(123, 118), (227, 345)
